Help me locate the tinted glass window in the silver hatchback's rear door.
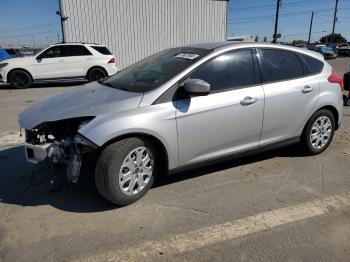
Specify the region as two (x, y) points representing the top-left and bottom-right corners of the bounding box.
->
(260, 49), (303, 83)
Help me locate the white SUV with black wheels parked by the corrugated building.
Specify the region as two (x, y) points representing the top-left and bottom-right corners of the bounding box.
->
(0, 43), (118, 88)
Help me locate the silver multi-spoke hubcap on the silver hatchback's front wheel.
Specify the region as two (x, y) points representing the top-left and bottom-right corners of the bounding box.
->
(119, 146), (154, 196)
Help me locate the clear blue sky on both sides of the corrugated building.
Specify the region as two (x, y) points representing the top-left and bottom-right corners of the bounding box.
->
(0, 0), (350, 46)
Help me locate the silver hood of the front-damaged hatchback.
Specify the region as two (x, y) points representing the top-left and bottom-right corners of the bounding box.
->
(19, 82), (143, 130)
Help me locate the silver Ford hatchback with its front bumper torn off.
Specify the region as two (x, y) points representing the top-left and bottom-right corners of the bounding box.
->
(19, 42), (343, 205)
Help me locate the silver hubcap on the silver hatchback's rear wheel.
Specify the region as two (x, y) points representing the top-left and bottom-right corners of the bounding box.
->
(310, 116), (332, 149)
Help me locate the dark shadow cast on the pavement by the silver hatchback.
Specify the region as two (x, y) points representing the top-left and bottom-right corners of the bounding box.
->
(0, 143), (302, 213)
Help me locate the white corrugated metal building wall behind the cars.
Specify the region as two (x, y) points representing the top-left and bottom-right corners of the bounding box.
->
(61, 0), (227, 69)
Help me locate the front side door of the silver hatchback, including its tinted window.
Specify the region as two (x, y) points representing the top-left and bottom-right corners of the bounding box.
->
(176, 49), (264, 165)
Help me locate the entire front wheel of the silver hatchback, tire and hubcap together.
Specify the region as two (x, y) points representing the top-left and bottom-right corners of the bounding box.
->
(95, 137), (158, 206)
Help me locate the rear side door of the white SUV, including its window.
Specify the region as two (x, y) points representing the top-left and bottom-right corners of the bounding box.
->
(66, 45), (93, 77)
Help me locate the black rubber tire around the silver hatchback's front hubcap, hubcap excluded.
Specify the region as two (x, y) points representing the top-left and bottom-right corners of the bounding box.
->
(95, 138), (158, 206)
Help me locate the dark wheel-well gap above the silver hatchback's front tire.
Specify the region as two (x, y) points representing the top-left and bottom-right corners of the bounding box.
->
(102, 133), (169, 175)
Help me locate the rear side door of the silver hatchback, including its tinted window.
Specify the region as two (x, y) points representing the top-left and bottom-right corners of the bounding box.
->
(259, 49), (319, 145)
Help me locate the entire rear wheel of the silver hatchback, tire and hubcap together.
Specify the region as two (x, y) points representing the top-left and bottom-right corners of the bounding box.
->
(301, 109), (335, 155)
